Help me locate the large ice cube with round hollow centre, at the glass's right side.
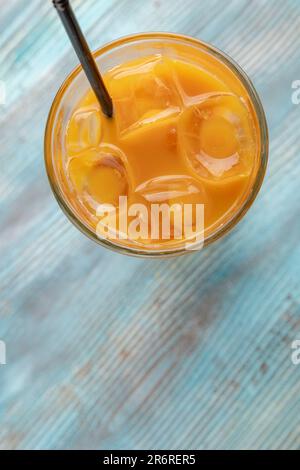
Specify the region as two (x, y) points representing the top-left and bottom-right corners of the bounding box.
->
(178, 93), (256, 179)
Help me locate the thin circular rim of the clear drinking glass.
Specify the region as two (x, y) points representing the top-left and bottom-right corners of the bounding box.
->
(44, 31), (269, 258)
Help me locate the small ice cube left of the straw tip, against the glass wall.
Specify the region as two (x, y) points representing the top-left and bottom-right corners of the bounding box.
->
(66, 106), (101, 155)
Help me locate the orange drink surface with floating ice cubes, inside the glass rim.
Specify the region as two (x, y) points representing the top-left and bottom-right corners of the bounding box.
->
(60, 48), (259, 250)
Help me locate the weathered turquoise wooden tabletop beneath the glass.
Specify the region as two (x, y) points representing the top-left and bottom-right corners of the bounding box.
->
(0, 0), (300, 449)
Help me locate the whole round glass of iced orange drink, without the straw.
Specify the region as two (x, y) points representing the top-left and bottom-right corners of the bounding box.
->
(46, 34), (267, 255)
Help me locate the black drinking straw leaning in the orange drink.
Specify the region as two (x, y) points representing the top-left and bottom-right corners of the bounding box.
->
(52, 0), (113, 117)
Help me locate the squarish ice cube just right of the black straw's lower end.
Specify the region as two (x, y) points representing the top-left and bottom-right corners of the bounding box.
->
(108, 54), (182, 136)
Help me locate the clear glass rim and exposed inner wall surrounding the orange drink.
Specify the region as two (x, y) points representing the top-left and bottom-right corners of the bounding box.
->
(45, 33), (268, 257)
